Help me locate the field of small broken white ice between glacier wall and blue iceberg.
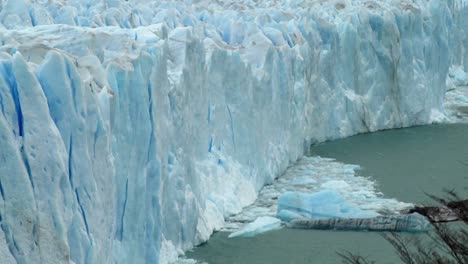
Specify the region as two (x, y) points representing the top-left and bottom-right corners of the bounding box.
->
(229, 157), (412, 231)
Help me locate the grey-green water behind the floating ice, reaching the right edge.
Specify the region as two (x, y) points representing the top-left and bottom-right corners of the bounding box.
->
(309, 124), (468, 203)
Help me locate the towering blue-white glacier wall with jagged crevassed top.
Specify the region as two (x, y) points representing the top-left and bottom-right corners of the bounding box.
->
(0, 0), (468, 263)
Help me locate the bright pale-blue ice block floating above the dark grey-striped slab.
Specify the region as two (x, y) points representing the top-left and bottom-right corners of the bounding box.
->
(277, 190), (379, 222)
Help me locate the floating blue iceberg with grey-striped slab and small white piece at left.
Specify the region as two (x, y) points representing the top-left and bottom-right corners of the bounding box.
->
(229, 190), (432, 238)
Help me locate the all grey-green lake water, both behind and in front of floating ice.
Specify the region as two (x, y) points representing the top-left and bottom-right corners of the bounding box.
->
(187, 124), (468, 264)
